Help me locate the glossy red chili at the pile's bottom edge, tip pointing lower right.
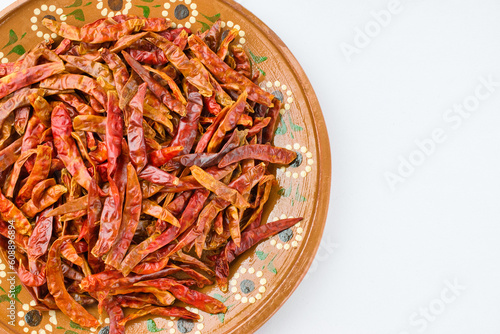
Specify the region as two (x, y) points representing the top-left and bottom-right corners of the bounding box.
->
(134, 278), (227, 314)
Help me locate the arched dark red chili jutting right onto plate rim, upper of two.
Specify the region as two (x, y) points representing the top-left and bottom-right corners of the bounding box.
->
(219, 144), (297, 167)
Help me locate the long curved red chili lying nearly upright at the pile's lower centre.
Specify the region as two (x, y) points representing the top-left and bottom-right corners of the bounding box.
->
(106, 164), (142, 268)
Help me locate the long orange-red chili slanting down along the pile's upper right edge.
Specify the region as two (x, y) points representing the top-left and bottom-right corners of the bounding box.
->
(188, 35), (274, 106)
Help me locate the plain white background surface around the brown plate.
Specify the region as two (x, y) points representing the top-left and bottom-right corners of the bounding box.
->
(0, 0), (500, 334)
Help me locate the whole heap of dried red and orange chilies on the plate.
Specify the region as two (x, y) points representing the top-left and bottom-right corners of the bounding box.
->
(0, 15), (300, 333)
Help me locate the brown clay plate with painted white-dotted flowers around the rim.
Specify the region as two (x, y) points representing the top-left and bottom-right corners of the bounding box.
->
(0, 0), (331, 334)
